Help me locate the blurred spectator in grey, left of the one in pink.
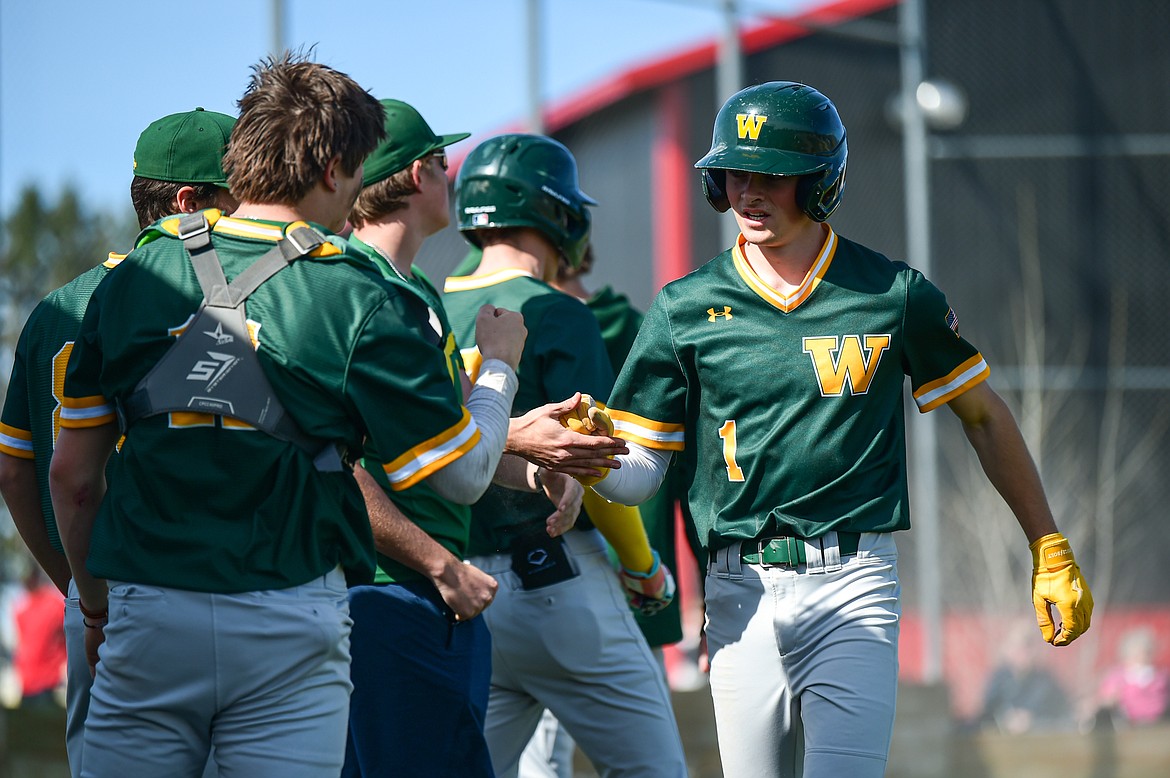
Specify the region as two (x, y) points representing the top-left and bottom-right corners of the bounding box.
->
(979, 622), (1073, 735)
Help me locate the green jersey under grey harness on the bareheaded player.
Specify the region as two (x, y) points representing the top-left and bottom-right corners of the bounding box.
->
(61, 212), (480, 592)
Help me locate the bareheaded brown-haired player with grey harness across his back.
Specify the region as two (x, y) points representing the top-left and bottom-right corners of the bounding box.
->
(49, 54), (524, 778)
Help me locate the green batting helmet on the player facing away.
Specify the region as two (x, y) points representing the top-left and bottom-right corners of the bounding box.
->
(455, 135), (597, 267)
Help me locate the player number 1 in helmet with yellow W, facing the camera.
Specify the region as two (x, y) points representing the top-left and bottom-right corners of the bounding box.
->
(594, 82), (1093, 778)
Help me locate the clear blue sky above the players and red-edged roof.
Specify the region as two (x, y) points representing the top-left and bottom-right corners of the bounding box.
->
(0, 0), (825, 214)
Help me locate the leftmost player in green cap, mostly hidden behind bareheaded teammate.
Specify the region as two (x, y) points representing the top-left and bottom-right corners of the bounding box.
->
(0, 108), (236, 778)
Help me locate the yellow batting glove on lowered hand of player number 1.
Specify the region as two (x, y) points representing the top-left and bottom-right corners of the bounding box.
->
(1028, 532), (1093, 646)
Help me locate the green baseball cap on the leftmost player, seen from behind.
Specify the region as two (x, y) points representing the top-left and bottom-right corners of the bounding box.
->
(135, 108), (235, 187)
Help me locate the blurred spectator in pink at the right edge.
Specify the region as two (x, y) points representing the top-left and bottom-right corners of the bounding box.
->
(1097, 627), (1170, 724)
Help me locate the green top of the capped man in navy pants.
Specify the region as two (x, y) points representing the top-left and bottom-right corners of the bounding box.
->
(350, 237), (472, 584)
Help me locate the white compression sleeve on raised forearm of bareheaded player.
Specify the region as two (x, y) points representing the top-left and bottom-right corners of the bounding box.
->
(427, 359), (519, 505)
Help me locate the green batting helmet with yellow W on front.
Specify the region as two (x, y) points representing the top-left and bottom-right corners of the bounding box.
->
(695, 81), (848, 221)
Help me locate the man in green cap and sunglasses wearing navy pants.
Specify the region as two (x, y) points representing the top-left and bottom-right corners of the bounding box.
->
(342, 99), (594, 778)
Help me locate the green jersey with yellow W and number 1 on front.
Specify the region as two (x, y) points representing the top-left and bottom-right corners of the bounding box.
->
(610, 229), (987, 550)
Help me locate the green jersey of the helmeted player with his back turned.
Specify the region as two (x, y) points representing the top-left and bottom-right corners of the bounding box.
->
(443, 270), (613, 556)
